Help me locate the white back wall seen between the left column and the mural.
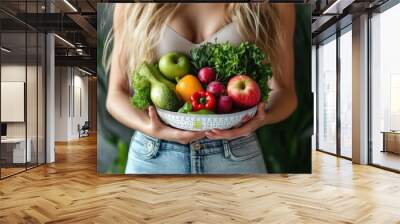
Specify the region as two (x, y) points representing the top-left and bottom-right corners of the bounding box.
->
(55, 67), (88, 141)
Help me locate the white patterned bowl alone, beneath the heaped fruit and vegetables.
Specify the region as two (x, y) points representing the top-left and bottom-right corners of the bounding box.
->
(157, 106), (257, 131)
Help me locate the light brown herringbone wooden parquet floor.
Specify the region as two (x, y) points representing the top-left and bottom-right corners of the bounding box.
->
(0, 134), (400, 224)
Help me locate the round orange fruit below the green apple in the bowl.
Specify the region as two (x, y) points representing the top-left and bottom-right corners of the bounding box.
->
(175, 74), (203, 102)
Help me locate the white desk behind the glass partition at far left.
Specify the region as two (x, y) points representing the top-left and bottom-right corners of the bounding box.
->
(1, 138), (32, 163)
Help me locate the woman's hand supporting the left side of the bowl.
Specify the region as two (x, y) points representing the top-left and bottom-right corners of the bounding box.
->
(145, 106), (205, 144)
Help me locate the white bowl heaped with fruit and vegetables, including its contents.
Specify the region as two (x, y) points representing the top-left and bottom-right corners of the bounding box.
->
(131, 42), (272, 131)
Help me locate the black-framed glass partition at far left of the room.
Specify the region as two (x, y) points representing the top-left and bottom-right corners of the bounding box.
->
(0, 1), (46, 179)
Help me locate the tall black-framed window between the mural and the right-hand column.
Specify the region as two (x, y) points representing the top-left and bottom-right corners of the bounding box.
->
(316, 25), (353, 158)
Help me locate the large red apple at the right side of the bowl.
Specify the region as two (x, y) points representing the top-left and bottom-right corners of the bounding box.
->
(227, 75), (261, 108)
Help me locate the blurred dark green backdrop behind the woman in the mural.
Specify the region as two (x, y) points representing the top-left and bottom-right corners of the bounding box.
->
(97, 3), (313, 174)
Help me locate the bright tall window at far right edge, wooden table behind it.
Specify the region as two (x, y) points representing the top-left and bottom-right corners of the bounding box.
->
(370, 1), (400, 170)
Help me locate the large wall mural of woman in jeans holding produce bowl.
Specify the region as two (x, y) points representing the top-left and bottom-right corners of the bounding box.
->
(97, 3), (313, 174)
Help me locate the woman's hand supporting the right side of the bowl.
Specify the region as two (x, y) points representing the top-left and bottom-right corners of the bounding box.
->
(205, 102), (267, 140)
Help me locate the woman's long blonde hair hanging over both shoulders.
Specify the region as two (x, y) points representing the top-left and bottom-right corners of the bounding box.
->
(103, 2), (282, 81)
